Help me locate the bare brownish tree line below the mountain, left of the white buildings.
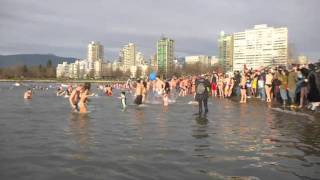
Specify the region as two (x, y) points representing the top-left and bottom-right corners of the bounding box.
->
(0, 59), (56, 79)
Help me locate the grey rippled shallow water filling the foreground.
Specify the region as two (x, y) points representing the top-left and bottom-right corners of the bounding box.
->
(0, 83), (320, 180)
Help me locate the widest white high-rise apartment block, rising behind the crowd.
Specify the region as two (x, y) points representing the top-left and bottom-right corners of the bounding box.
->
(233, 24), (288, 71)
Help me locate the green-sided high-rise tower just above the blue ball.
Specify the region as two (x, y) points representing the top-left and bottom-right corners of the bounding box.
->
(157, 37), (174, 77)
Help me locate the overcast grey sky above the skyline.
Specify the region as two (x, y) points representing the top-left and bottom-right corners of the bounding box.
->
(0, 0), (320, 60)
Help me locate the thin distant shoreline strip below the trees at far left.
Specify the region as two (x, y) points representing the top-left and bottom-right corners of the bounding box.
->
(0, 79), (126, 83)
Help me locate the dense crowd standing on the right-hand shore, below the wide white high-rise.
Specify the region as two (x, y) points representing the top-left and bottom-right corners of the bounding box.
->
(216, 64), (320, 110)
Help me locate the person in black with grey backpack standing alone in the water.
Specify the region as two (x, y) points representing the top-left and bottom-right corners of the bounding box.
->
(195, 76), (210, 115)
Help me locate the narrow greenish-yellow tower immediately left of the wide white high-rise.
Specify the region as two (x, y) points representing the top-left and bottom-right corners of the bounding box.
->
(218, 31), (233, 72)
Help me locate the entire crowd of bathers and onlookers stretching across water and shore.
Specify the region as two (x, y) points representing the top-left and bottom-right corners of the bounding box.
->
(24, 64), (320, 113)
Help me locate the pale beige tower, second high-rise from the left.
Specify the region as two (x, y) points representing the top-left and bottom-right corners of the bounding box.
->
(121, 43), (136, 71)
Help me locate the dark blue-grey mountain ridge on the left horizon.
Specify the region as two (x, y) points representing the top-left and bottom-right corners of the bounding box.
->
(0, 54), (77, 68)
